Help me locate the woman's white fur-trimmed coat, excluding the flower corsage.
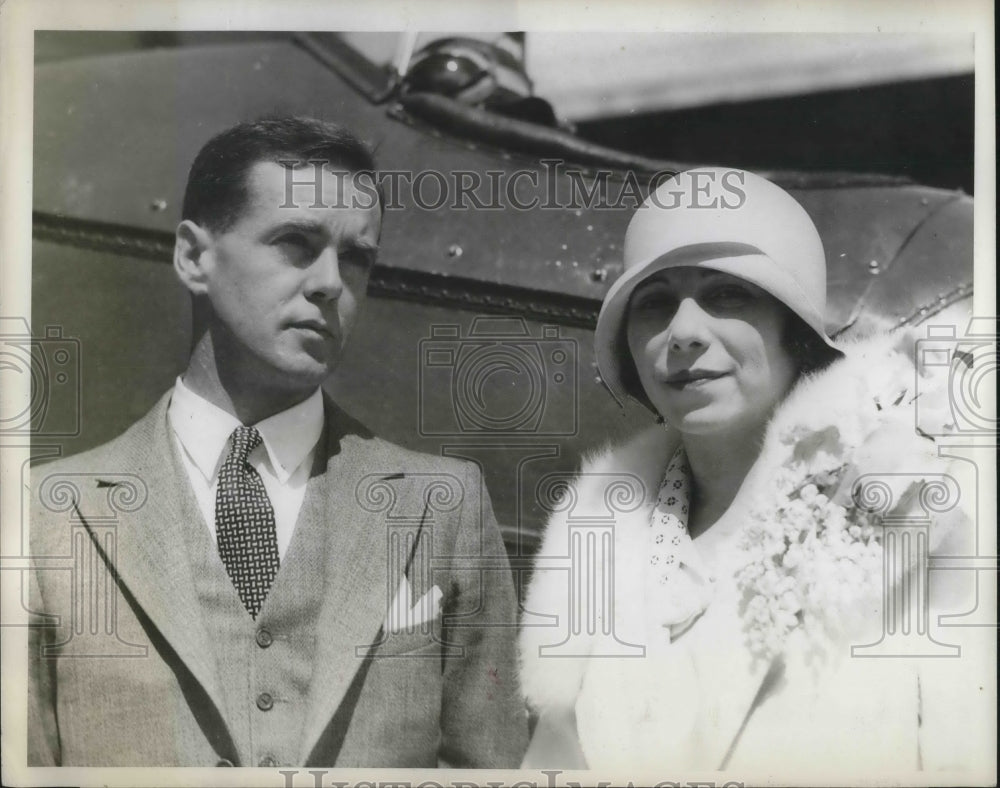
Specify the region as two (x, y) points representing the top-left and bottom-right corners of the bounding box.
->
(520, 333), (988, 779)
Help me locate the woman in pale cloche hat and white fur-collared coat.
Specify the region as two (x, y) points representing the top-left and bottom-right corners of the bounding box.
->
(520, 169), (984, 778)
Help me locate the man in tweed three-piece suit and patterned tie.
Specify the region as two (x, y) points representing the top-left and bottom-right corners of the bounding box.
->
(29, 118), (527, 767)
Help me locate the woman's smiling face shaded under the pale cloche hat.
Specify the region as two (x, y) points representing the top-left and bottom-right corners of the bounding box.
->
(627, 268), (796, 435)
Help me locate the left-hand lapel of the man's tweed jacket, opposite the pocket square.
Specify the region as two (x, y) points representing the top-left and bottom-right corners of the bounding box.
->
(78, 393), (225, 728)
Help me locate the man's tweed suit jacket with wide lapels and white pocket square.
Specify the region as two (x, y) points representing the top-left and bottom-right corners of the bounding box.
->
(28, 393), (527, 768)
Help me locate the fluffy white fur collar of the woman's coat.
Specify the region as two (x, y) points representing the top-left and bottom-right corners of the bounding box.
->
(520, 332), (940, 710)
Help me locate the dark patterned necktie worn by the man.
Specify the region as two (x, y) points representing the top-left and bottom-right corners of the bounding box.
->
(215, 427), (279, 619)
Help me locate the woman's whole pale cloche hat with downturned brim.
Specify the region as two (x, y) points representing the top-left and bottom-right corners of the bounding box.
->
(594, 167), (839, 401)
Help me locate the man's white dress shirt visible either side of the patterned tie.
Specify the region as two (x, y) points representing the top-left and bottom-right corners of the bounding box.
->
(167, 377), (323, 558)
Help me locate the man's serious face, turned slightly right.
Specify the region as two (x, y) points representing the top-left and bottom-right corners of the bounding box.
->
(197, 162), (381, 390)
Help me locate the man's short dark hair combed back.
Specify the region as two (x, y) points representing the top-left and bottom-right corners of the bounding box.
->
(181, 117), (385, 232)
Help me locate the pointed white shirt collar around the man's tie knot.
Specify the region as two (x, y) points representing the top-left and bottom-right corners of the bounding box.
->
(168, 377), (323, 484)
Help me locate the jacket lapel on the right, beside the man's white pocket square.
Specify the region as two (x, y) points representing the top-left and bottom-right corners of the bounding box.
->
(297, 401), (410, 763)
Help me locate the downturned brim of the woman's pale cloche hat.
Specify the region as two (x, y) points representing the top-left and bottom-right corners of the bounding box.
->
(594, 242), (841, 405)
